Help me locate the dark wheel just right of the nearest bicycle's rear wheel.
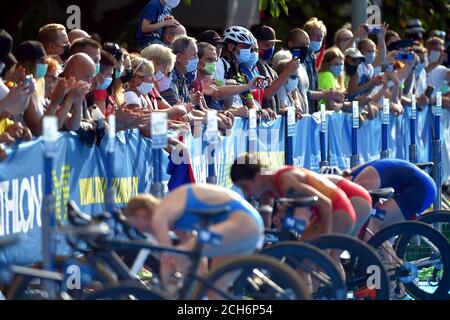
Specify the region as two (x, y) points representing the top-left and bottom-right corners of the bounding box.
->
(260, 241), (347, 300)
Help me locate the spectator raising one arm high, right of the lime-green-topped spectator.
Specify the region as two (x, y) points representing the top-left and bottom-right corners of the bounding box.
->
(348, 24), (388, 100)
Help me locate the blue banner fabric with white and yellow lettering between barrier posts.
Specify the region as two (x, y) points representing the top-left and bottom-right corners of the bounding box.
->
(0, 107), (450, 265)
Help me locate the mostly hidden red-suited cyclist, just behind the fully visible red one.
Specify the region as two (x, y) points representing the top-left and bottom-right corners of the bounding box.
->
(319, 167), (372, 236)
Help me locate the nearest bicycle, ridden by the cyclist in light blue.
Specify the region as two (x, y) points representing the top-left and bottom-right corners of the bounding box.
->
(6, 202), (309, 300)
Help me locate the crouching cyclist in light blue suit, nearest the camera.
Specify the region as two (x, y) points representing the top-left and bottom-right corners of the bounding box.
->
(125, 184), (264, 290)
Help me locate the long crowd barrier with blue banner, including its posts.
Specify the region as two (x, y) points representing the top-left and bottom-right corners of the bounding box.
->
(0, 103), (450, 267)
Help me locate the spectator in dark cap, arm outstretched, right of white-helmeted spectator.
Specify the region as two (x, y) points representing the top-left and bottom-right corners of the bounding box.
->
(252, 26), (300, 113)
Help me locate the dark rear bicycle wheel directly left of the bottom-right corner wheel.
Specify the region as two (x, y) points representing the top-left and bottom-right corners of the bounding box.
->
(306, 235), (389, 300)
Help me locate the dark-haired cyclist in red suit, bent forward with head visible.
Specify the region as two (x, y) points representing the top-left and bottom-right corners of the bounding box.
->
(231, 154), (355, 239)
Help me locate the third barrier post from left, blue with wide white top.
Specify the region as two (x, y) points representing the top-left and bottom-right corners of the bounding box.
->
(150, 112), (168, 198)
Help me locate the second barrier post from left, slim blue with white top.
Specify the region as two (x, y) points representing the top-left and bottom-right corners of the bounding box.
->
(105, 114), (116, 212)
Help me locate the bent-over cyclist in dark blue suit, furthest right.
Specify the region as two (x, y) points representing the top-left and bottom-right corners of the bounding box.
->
(344, 159), (437, 232)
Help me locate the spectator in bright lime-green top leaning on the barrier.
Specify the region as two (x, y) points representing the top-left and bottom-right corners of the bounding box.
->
(319, 47), (345, 110)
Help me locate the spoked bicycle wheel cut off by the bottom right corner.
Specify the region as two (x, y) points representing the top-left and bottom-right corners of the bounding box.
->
(368, 222), (450, 300)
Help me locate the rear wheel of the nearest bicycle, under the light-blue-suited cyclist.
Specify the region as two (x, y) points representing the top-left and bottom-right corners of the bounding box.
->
(192, 255), (310, 300)
